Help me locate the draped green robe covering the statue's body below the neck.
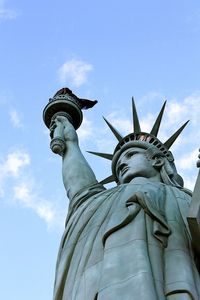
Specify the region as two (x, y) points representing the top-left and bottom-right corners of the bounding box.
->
(54, 178), (200, 300)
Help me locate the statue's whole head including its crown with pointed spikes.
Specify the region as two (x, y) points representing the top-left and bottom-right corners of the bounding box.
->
(90, 101), (188, 187)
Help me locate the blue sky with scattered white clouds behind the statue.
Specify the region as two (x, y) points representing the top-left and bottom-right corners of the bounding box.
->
(0, 0), (200, 300)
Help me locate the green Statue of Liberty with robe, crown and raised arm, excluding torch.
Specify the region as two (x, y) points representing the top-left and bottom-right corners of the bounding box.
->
(43, 89), (200, 300)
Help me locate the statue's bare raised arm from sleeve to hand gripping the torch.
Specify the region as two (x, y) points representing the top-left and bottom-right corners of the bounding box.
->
(51, 116), (97, 199)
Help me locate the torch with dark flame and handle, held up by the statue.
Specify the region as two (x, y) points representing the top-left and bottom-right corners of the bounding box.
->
(43, 88), (97, 155)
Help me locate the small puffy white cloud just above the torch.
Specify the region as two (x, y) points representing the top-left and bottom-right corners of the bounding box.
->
(58, 59), (93, 87)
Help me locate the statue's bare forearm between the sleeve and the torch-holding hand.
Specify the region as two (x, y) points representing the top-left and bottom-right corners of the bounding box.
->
(63, 142), (97, 199)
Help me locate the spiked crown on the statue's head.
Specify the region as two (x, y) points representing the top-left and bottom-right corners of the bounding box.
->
(88, 98), (189, 184)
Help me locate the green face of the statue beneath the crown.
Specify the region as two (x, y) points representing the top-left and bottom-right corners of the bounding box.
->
(116, 147), (160, 183)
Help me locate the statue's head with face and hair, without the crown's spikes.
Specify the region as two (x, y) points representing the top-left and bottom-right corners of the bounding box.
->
(112, 141), (183, 187)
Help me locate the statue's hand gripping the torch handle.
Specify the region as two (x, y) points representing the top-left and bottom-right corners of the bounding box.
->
(50, 116), (78, 143)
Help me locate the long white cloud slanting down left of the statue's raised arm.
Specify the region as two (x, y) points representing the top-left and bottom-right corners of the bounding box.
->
(0, 149), (64, 228)
